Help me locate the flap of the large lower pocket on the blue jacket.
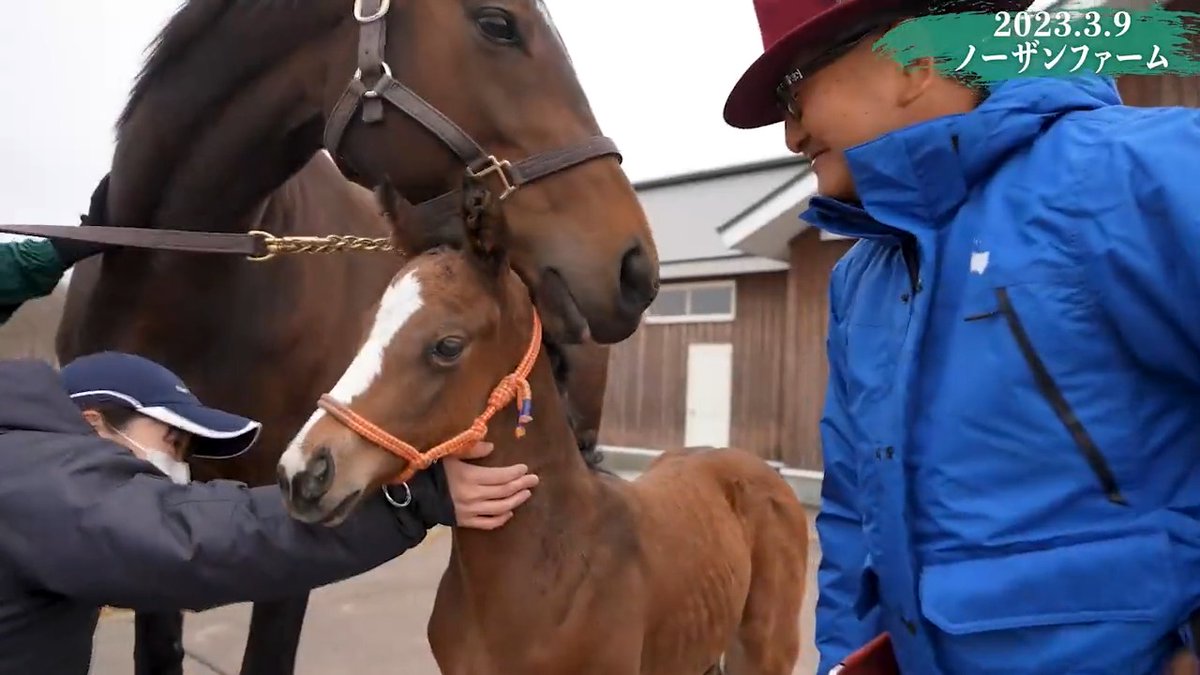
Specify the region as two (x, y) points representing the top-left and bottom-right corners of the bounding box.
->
(920, 533), (1178, 635)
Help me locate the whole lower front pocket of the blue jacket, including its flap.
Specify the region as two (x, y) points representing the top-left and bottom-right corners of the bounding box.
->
(920, 531), (1180, 675)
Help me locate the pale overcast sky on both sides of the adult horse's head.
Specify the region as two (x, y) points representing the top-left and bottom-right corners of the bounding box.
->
(0, 0), (786, 225)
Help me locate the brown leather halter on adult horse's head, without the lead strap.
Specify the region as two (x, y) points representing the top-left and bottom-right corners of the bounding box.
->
(324, 0), (620, 223)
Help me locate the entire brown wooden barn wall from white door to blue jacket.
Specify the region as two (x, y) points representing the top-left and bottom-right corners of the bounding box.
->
(600, 229), (852, 471)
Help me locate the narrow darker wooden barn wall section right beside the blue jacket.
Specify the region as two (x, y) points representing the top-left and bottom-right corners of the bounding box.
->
(780, 228), (853, 471)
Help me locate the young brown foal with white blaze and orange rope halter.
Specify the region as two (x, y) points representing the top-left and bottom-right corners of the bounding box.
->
(280, 181), (808, 675)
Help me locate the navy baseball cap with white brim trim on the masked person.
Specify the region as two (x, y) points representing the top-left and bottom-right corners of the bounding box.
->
(61, 352), (263, 459)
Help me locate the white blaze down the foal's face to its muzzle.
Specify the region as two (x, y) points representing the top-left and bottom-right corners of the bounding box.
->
(280, 269), (424, 480)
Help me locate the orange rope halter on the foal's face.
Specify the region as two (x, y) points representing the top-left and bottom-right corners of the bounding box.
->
(318, 310), (541, 484)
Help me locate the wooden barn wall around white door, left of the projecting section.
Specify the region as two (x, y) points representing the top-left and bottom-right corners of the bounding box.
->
(600, 271), (787, 459)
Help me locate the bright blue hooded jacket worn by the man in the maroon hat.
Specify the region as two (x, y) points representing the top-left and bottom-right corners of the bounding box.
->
(802, 77), (1200, 675)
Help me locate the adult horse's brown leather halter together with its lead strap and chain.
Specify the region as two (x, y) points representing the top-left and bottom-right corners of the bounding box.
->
(0, 0), (622, 261)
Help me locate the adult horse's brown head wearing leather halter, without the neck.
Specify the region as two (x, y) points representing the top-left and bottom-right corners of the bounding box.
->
(325, 0), (658, 344)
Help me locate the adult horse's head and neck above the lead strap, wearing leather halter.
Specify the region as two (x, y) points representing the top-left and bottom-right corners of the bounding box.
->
(113, 0), (658, 344)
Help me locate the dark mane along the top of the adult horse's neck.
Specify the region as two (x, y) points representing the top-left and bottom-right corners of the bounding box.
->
(118, 0), (350, 133)
